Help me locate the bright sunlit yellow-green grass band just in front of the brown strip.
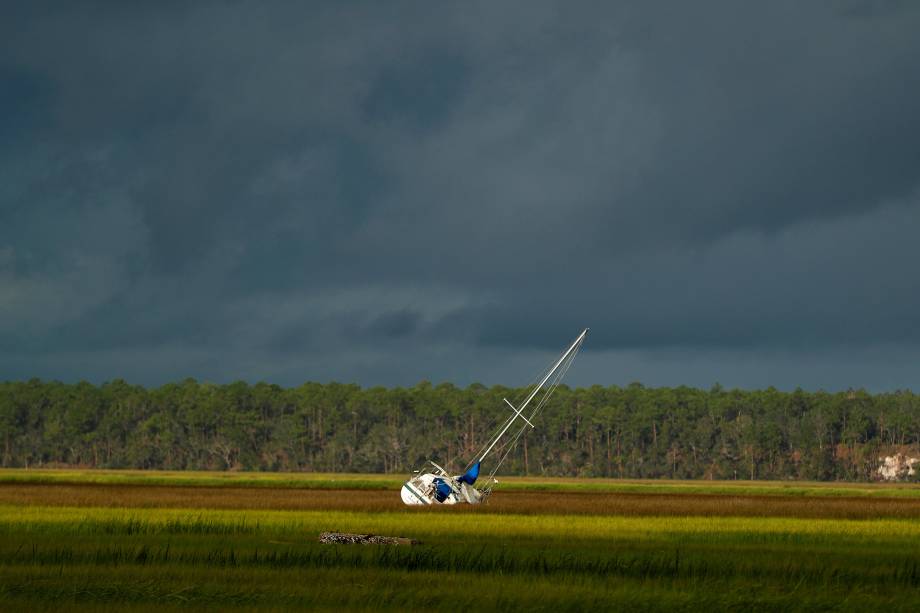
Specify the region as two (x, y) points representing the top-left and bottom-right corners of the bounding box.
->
(0, 506), (920, 547)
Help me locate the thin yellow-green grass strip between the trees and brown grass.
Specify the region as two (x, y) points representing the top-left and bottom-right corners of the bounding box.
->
(7, 468), (920, 498)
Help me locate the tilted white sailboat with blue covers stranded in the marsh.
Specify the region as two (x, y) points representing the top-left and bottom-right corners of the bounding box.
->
(400, 328), (588, 505)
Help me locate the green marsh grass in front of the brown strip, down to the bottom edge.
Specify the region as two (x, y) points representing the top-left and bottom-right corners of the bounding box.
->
(0, 504), (920, 611)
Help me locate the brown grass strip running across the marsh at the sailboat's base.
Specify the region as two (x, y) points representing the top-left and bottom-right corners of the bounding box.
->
(0, 484), (920, 519)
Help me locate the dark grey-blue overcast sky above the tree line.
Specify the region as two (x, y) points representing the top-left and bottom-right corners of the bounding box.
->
(0, 0), (920, 390)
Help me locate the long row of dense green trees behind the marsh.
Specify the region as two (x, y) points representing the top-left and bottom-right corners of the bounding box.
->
(0, 379), (920, 481)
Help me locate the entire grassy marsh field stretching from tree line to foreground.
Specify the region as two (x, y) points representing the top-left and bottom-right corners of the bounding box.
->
(0, 471), (920, 611)
